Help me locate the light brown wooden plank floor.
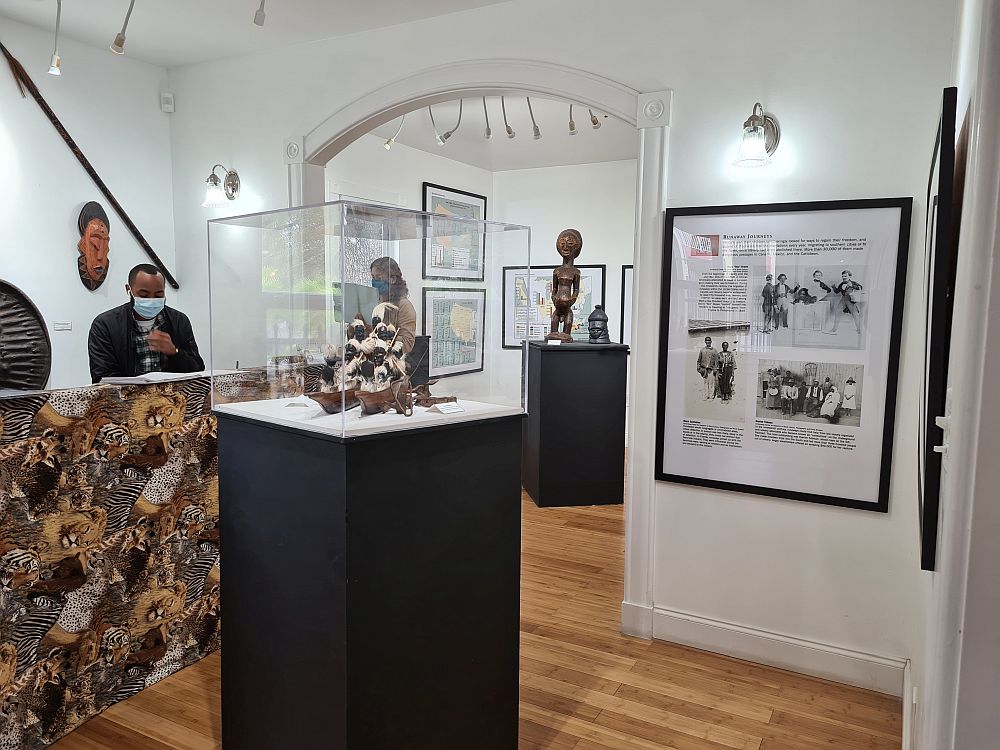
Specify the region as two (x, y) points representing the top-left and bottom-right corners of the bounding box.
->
(52, 501), (901, 750)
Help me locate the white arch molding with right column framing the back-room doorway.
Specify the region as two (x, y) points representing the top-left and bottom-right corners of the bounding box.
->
(283, 60), (672, 638)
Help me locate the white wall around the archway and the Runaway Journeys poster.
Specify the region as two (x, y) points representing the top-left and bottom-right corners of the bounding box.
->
(164, 0), (955, 700)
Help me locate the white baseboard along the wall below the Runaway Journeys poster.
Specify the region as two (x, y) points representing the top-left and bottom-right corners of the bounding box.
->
(652, 604), (907, 696)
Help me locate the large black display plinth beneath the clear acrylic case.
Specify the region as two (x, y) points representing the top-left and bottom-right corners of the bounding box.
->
(217, 413), (523, 750)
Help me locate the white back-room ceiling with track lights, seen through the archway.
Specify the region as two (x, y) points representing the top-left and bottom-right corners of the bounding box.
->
(372, 96), (639, 172)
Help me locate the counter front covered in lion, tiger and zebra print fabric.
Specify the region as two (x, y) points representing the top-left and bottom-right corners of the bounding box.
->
(0, 378), (220, 750)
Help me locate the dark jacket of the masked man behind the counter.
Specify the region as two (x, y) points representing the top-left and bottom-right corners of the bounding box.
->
(87, 302), (205, 383)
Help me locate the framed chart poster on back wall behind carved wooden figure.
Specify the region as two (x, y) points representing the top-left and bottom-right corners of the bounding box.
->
(503, 265), (606, 349)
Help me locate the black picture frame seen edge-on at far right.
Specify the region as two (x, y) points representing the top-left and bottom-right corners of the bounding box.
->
(917, 86), (967, 570)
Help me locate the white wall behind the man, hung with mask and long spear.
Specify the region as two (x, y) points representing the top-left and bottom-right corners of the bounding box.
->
(0, 17), (176, 388)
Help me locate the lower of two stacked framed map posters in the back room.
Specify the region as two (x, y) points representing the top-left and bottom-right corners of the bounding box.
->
(423, 288), (486, 378)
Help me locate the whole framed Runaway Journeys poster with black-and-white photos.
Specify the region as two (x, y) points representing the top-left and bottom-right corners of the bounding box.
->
(656, 198), (913, 512)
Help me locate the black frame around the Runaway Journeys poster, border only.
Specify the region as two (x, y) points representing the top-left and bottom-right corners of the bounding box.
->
(654, 198), (913, 513)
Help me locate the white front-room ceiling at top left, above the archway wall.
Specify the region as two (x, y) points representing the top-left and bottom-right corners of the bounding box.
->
(0, 0), (505, 67)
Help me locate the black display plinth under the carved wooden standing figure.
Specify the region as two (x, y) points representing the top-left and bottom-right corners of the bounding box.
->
(521, 341), (628, 507)
